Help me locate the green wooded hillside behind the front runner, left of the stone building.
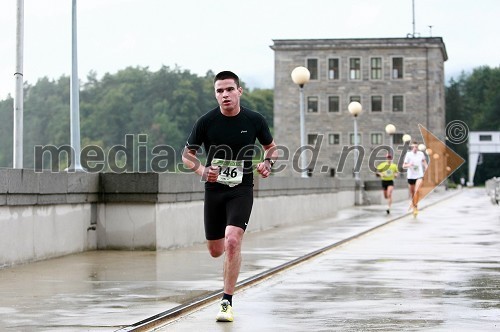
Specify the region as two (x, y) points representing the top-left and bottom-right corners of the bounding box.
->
(0, 66), (273, 170)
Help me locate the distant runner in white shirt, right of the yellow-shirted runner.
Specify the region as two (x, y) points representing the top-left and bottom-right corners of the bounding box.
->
(403, 141), (427, 216)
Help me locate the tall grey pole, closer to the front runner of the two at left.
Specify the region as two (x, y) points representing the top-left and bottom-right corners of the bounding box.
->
(70, 0), (82, 171)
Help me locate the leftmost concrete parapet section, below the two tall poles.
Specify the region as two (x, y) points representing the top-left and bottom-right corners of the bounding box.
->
(0, 169), (99, 267)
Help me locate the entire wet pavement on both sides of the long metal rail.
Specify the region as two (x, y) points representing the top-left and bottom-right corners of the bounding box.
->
(0, 189), (500, 331)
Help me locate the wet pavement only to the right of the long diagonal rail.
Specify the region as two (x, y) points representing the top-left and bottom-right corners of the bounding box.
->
(162, 190), (500, 332)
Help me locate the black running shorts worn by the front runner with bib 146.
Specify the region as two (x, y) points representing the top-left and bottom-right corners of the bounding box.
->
(204, 185), (253, 240)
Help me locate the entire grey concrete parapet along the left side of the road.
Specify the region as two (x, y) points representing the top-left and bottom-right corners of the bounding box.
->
(0, 169), (402, 267)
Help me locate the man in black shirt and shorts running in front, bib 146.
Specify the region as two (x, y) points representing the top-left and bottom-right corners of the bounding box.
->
(182, 71), (278, 322)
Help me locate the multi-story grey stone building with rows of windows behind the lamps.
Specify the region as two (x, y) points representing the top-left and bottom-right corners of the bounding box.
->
(271, 37), (448, 178)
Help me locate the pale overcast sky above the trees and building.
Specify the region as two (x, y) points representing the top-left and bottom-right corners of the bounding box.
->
(0, 0), (500, 99)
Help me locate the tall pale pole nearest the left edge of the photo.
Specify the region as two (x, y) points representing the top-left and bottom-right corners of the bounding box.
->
(13, 0), (24, 168)
